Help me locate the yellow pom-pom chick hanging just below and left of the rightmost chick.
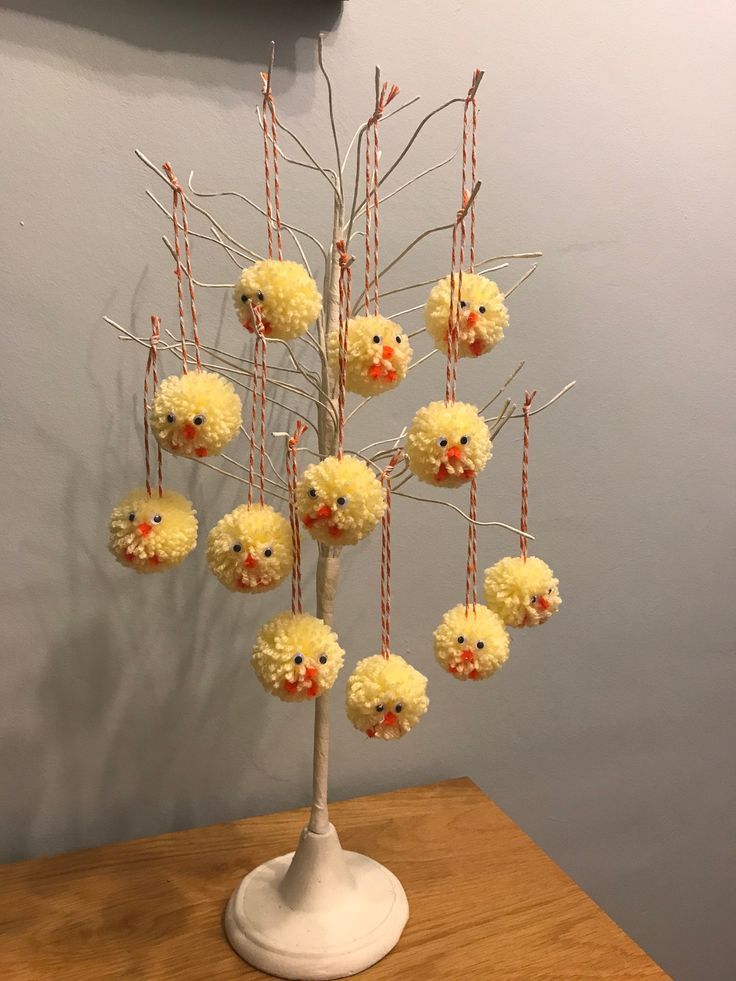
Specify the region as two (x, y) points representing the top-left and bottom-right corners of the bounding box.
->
(434, 603), (509, 681)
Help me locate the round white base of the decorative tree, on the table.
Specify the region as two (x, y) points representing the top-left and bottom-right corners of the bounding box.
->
(225, 825), (409, 981)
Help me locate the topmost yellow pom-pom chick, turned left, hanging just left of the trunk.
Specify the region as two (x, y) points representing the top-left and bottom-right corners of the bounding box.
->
(233, 259), (322, 341)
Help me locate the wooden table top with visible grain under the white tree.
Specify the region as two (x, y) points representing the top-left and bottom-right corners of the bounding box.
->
(0, 778), (667, 981)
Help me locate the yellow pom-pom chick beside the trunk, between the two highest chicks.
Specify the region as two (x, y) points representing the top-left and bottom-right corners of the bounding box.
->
(328, 316), (412, 396)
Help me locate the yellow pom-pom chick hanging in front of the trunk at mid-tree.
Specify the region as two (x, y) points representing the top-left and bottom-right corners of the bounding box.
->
(296, 456), (386, 545)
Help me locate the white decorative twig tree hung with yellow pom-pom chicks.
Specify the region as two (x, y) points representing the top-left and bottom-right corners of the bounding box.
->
(106, 39), (573, 978)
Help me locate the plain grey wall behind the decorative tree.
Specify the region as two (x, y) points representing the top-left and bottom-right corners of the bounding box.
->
(0, 0), (736, 981)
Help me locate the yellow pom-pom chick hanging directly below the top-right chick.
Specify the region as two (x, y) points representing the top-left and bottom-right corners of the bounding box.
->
(406, 402), (491, 487)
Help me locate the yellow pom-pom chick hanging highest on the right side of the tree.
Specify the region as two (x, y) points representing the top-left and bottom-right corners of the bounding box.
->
(424, 272), (509, 358)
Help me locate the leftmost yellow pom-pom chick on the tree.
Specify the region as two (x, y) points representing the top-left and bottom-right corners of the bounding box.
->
(108, 487), (197, 572)
